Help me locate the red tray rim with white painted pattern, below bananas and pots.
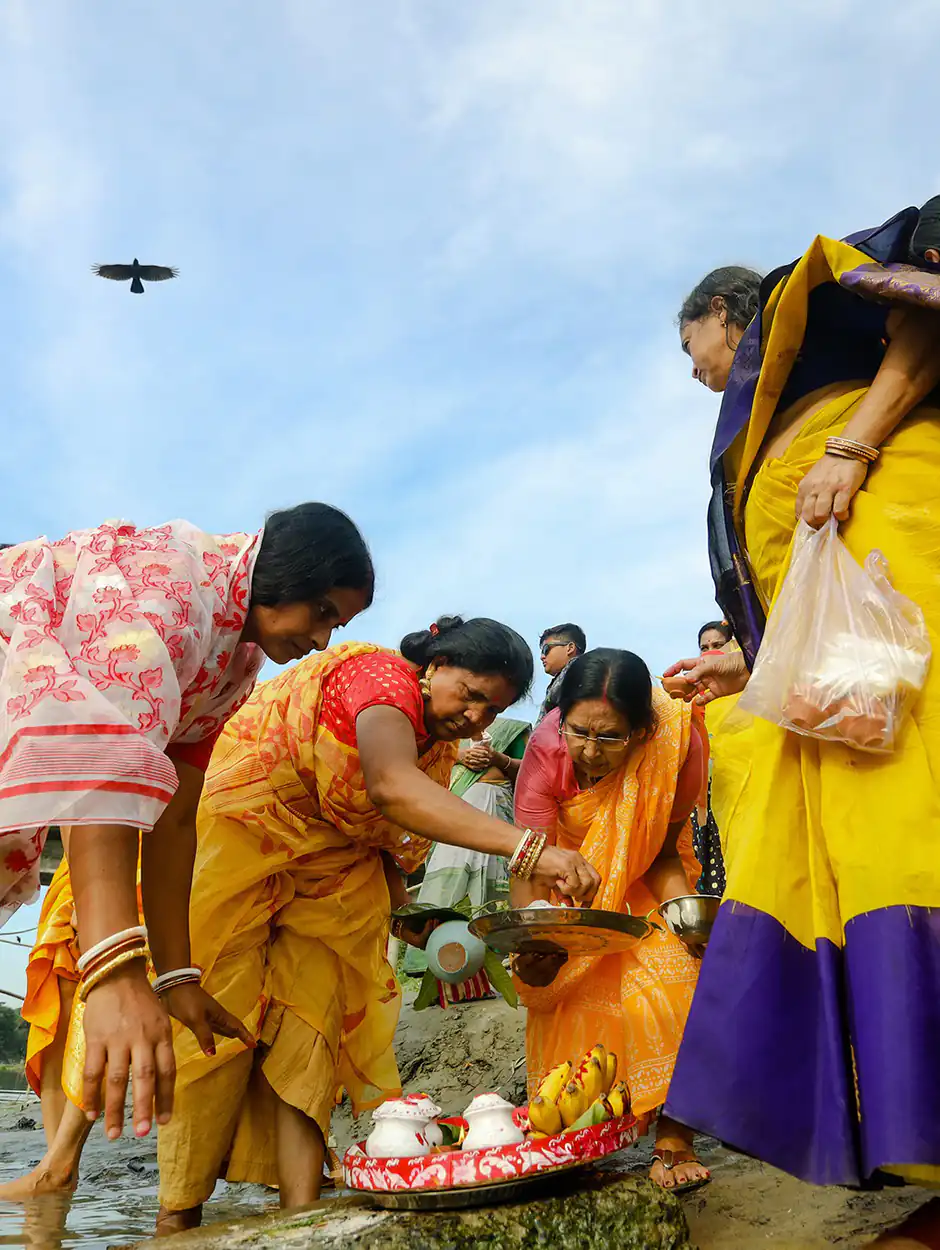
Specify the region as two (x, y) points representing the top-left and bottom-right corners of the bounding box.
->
(343, 1115), (638, 1196)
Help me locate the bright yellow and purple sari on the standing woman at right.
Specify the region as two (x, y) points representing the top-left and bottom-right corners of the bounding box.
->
(666, 215), (940, 1186)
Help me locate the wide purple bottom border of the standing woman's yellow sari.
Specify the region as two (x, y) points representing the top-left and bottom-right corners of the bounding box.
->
(665, 903), (940, 1186)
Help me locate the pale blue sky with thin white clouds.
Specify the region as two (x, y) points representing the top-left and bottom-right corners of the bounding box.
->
(0, 0), (940, 991)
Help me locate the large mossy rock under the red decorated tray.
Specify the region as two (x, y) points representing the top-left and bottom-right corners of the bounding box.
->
(130, 1175), (693, 1250)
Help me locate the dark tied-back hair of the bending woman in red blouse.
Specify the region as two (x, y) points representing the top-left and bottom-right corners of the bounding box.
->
(400, 616), (535, 699)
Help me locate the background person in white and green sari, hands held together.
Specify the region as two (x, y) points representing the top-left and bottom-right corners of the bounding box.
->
(404, 716), (533, 1005)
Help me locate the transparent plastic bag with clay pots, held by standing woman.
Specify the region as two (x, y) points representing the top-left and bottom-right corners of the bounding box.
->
(739, 519), (930, 753)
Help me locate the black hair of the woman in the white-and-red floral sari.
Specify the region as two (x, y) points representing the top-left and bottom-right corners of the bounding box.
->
(251, 504), (375, 608)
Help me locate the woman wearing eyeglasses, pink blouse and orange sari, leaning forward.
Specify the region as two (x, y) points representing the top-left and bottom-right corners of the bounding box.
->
(510, 648), (709, 1190)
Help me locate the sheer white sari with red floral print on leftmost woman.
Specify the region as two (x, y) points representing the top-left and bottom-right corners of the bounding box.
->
(0, 521), (264, 924)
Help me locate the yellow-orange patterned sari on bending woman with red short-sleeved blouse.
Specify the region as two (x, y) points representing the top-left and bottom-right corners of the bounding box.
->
(159, 643), (456, 1210)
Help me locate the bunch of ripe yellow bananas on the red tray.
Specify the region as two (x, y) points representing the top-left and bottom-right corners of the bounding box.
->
(529, 1044), (630, 1136)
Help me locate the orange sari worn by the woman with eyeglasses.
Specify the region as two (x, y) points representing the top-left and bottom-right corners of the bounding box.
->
(516, 690), (699, 1116)
